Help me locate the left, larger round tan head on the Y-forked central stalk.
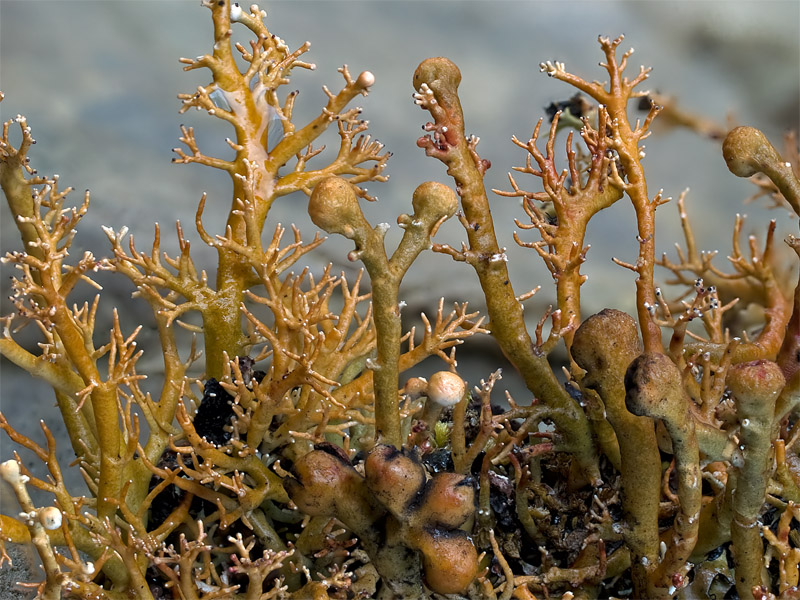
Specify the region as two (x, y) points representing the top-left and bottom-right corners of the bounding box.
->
(308, 177), (369, 239)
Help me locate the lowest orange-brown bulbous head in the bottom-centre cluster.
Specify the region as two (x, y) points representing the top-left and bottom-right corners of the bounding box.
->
(409, 529), (478, 594)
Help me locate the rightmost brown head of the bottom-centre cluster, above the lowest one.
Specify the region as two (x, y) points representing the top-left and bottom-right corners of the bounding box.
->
(412, 473), (475, 529)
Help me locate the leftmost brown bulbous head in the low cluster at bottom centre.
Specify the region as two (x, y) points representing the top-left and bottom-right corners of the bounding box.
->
(283, 450), (364, 516)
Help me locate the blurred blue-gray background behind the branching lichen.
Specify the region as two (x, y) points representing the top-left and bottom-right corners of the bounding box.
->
(0, 0), (800, 580)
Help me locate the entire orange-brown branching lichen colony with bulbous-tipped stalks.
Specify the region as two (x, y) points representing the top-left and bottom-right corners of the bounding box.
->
(0, 0), (800, 600)
